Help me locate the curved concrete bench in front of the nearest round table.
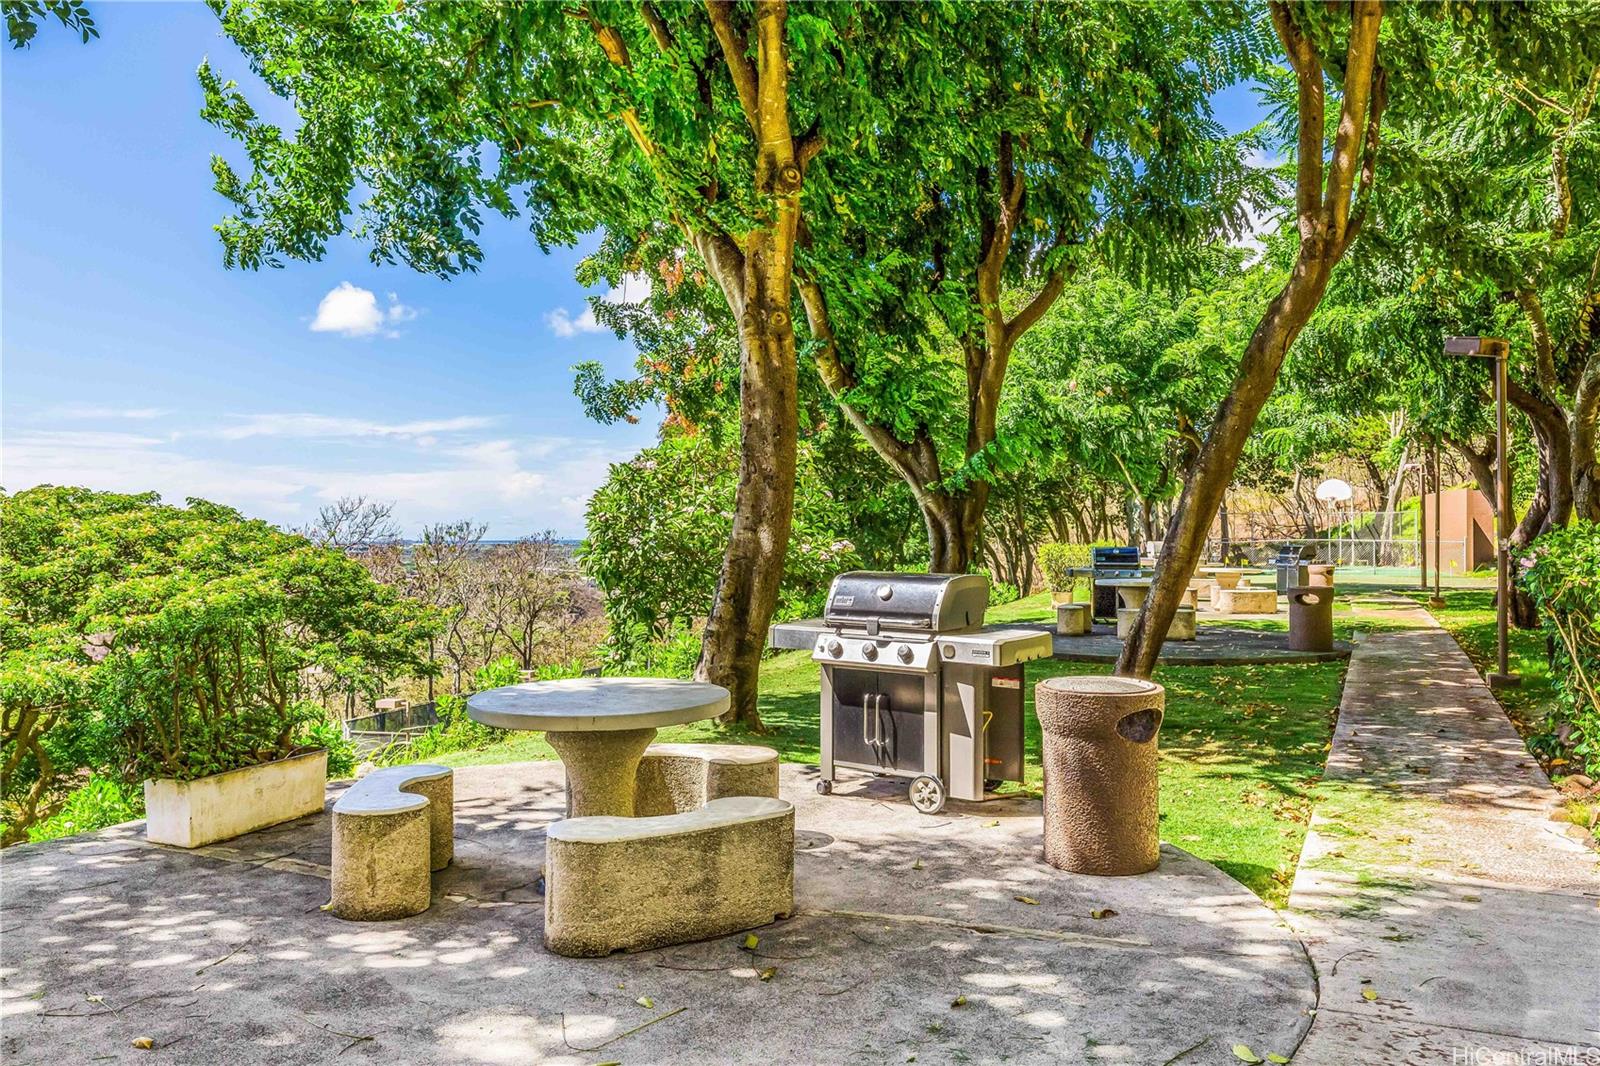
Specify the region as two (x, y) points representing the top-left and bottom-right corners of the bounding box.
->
(544, 795), (795, 957)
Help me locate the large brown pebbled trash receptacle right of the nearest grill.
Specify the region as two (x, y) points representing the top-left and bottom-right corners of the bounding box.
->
(1034, 675), (1166, 876)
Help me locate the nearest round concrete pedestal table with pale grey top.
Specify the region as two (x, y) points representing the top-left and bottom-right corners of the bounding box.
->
(467, 677), (728, 818)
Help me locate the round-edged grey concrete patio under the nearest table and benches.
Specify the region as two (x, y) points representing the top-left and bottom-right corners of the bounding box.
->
(0, 763), (1315, 1066)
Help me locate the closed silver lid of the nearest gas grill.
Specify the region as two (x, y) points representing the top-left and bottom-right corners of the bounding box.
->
(822, 570), (989, 634)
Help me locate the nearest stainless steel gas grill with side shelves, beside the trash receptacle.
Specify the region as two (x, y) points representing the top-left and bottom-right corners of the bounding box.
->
(771, 571), (1053, 815)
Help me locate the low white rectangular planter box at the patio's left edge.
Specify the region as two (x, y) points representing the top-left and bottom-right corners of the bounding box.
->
(144, 751), (328, 848)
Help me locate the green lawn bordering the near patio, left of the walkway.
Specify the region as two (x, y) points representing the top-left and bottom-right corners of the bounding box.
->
(438, 630), (1344, 906)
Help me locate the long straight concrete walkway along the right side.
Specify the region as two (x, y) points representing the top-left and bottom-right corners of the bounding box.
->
(1290, 602), (1600, 1066)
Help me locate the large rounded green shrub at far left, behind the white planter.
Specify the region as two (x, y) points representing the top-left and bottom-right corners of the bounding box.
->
(0, 487), (440, 844)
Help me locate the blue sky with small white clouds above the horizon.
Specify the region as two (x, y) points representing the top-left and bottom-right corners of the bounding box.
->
(0, 2), (1256, 536)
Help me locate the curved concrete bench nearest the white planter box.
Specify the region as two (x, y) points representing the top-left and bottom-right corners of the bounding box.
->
(328, 763), (456, 922)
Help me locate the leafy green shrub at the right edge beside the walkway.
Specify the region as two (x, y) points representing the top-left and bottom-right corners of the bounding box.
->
(1520, 522), (1600, 770)
